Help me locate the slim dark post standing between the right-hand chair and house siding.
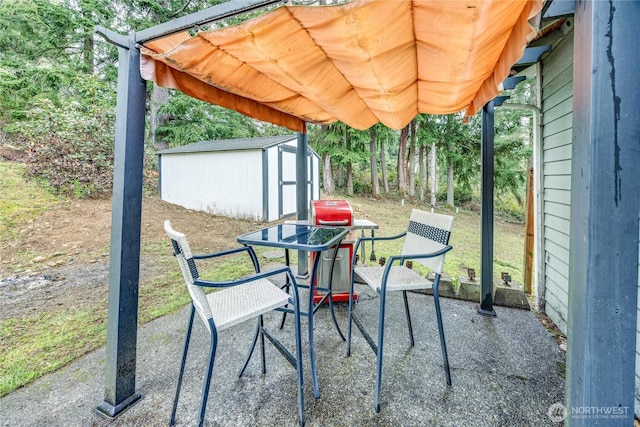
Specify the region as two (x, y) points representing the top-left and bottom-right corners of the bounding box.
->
(478, 101), (496, 316)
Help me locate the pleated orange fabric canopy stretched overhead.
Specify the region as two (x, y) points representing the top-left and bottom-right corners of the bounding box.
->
(141, 0), (542, 131)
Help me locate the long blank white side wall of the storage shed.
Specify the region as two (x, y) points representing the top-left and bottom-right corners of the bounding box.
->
(160, 150), (264, 220)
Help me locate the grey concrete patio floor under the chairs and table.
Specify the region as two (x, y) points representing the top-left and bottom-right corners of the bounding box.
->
(0, 286), (565, 426)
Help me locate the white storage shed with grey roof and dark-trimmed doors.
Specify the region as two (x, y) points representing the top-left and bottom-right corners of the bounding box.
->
(157, 135), (320, 221)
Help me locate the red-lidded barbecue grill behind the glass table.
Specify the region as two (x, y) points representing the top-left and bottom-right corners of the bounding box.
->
(311, 200), (357, 302)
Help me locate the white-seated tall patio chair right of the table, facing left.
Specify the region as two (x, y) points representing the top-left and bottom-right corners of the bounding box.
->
(347, 209), (453, 412)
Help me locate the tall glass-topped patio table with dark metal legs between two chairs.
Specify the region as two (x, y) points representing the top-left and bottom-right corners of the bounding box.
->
(237, 224), (349, 398)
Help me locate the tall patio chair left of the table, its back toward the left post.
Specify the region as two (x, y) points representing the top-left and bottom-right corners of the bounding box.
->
(164, 220), (304, 426)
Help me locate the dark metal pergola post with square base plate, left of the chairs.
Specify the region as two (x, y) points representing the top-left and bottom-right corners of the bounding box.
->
(96, 41), (146, 417)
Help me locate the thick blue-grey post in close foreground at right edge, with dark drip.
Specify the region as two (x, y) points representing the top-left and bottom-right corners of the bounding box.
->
(566, 1), (640, 426)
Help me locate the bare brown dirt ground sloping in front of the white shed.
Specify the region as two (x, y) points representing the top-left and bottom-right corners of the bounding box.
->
(0, 196), (258, 321)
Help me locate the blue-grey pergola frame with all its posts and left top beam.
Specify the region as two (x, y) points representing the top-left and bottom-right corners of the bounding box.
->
(96, 0), (640, 425)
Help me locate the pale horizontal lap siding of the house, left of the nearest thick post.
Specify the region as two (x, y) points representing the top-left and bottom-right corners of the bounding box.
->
(542, 34), (573, 334)
